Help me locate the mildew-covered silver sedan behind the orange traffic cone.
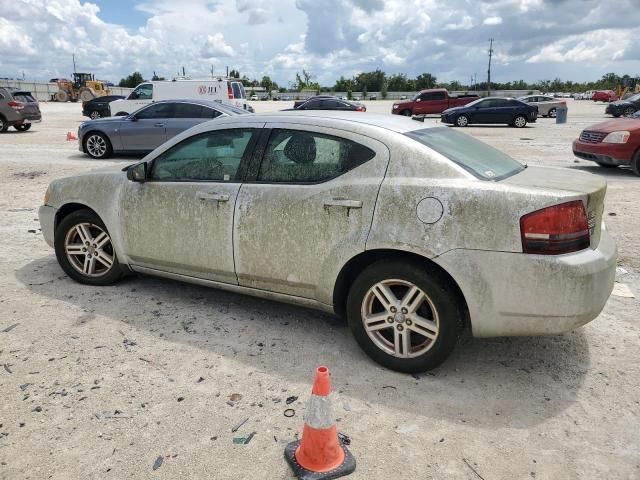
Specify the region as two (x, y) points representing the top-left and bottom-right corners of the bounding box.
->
(39, 112), (616, 372)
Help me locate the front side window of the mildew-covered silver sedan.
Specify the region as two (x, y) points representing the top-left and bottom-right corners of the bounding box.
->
(150, 129), (255, 182)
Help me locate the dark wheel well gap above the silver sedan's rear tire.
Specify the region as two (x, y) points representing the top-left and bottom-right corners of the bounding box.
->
(333, 249), (469, 325)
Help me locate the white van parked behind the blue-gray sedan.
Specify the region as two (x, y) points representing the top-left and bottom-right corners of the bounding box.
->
(109, 78), (247, 116)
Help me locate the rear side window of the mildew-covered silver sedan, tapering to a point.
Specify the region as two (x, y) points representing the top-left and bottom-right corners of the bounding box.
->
(258, 129), (375, 183)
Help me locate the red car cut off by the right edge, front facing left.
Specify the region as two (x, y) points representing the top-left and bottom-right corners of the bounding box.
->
(573, 112), (640, 176)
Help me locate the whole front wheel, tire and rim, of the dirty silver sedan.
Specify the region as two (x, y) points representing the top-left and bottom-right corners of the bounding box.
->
(54, 210), (124, 285)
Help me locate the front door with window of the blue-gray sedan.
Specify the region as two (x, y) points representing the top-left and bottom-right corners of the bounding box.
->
(119, 102), (174, 152)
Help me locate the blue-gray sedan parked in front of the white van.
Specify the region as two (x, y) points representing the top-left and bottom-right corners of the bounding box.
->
(78, 100), (248, 159)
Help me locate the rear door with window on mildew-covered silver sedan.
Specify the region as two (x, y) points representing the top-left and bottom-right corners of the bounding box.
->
(233, 123), (389, 304)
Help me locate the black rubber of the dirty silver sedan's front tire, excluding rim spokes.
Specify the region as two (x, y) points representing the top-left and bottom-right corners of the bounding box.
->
(53, 210), (124, 285)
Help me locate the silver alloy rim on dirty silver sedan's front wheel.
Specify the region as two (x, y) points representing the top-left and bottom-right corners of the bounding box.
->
(64, 223), (114, 277)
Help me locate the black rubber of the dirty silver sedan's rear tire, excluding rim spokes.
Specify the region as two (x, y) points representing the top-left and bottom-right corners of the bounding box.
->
(347, 260), (464, 373)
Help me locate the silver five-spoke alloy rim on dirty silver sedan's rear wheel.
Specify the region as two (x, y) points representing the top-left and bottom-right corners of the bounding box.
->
(360, 279), (440, 358)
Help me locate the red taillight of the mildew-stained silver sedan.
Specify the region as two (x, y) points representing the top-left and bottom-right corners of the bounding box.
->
(520, 200), (591, 255)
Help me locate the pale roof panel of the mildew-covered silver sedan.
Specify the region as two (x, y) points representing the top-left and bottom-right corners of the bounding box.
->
(200, 110), (442, 133)
